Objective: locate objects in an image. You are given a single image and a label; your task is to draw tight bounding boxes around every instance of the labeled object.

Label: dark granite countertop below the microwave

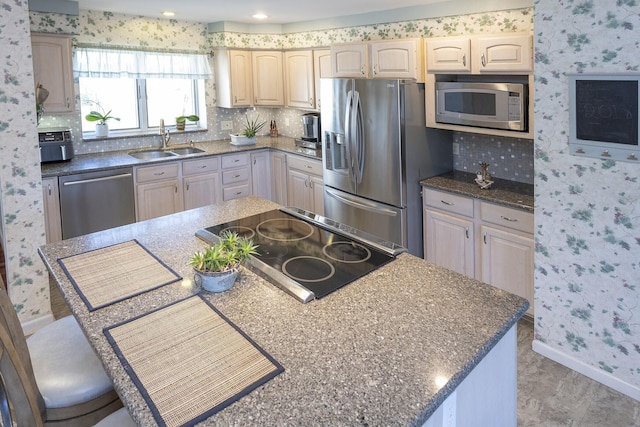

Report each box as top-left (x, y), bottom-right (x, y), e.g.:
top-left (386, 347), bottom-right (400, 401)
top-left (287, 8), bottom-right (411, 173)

top-left (420, 171), bottom-right (534, 212)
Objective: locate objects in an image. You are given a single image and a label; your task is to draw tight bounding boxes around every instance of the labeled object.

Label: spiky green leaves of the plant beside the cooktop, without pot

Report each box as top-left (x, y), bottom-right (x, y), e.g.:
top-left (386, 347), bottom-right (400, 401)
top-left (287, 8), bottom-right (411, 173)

top-left (189, 231), bottom-right (258, 273)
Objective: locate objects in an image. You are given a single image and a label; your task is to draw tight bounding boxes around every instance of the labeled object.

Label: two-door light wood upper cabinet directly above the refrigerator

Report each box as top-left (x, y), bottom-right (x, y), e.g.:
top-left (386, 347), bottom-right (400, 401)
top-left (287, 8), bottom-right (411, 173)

top-left (331, 39), bottom-right (423, 82)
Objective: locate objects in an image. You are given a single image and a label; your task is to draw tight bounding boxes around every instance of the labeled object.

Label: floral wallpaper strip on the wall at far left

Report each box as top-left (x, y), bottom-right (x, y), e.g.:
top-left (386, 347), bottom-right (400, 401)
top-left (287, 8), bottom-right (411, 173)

top-left (0, 0), bottom-right (50, 321)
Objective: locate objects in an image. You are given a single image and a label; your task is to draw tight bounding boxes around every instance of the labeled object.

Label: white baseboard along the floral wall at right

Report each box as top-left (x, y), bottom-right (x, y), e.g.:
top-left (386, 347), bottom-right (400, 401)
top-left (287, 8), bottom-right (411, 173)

top-left (532, 340), bottom-right (640, 400)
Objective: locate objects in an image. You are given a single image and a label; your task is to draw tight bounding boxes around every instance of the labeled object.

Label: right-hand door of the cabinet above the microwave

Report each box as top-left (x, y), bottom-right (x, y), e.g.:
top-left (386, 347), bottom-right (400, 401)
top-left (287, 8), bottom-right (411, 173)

top-left (471, 35), bottom-right (533, 73)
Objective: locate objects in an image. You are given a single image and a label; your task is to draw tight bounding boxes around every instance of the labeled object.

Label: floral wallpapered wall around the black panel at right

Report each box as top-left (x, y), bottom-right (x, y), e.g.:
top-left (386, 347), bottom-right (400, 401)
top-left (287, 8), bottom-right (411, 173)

top-left (534, 0), bottom-right (640, 398)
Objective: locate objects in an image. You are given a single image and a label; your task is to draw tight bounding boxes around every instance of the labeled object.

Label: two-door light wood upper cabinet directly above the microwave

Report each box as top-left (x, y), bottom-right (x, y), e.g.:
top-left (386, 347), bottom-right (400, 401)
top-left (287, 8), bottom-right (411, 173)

top-left (425, 33), bottom-right (533, 74)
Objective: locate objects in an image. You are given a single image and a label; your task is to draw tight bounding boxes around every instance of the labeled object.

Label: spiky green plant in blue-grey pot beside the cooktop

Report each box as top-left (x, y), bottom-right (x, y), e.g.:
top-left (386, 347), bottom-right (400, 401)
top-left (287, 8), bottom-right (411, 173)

top-left (189, 231), bottom-right (257, 292)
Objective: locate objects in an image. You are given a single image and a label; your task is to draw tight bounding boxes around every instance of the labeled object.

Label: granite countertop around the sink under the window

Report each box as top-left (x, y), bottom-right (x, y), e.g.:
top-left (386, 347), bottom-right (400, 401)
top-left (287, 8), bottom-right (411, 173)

top-left (41, 136), bottom-right (322, 178)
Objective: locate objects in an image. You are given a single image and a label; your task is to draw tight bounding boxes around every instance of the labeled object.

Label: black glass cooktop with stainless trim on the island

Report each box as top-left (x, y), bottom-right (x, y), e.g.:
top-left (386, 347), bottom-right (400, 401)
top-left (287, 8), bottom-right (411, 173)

top-left (196, 208), bottom-right (406, 303)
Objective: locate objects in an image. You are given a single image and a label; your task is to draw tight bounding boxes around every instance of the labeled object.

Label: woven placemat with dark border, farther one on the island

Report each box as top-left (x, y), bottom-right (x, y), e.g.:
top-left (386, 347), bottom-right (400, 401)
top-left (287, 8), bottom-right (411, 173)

top-left (58, 240), bottom-right (182, 311)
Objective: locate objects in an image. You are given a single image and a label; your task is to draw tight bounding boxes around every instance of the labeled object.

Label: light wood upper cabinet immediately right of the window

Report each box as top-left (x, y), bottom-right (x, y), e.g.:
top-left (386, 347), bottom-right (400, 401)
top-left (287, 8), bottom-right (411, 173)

top-left (213, 49), bottom-right (284, 108)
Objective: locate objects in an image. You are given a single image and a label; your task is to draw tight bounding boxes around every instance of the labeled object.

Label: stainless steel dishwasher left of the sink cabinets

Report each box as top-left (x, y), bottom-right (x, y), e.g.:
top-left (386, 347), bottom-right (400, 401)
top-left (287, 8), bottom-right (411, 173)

top-left (58, 168), bottom-right (136, 239)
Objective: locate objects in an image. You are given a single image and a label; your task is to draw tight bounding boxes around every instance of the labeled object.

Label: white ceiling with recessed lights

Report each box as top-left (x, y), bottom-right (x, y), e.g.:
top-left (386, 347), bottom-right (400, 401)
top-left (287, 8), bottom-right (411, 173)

top-left (78, 0), bottom-right (452, 24)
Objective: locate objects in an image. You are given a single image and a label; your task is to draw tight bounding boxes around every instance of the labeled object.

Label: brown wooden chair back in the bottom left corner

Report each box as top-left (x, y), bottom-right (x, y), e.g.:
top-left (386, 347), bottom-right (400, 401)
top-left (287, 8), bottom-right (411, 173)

top-left (0, 278), bottom-right (45, 426)
